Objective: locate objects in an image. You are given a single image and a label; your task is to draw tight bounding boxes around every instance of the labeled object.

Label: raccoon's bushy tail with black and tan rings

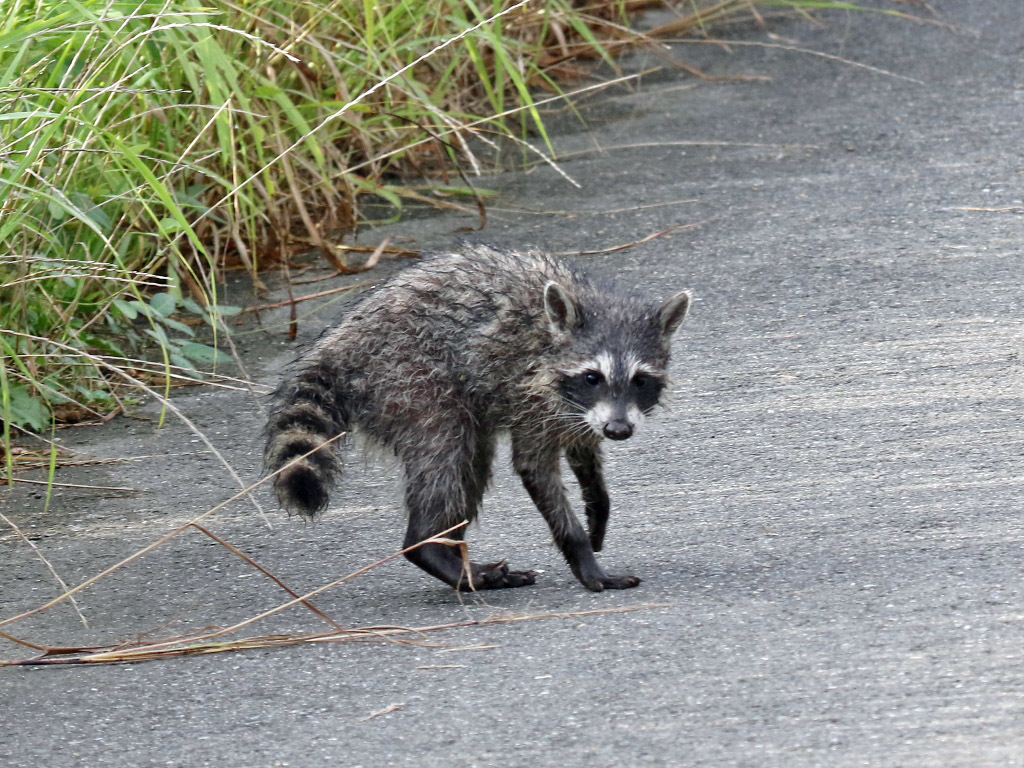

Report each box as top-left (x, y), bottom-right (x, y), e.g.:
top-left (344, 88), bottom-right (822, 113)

top-left (263, 361), bottom-right (348, 519)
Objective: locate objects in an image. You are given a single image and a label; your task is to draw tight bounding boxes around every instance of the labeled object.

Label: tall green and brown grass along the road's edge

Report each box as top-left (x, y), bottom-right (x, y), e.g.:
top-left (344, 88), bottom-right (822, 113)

top-left (0, 0), bottom-right (913, 456)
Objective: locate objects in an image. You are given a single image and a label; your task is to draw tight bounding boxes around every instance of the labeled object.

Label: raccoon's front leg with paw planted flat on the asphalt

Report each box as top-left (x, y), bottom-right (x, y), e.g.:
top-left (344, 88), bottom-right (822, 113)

top-left (512, 436), bottom-right (640, 592)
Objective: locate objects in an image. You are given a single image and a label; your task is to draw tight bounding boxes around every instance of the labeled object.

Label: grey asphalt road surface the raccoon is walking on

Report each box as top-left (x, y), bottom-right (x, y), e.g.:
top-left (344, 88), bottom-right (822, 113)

top-left (0, 0), bottom-right (1024, 768)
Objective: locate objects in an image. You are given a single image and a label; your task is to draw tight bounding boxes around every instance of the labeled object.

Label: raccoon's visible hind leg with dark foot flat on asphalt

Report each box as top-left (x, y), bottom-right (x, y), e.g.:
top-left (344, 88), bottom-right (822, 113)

top-left (404, 433), bottom-right (537, 590)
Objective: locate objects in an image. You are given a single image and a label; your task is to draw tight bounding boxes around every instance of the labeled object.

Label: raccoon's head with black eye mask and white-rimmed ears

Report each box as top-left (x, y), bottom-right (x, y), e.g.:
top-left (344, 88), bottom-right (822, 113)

top-left (544, 281), bottom-right (690, 440)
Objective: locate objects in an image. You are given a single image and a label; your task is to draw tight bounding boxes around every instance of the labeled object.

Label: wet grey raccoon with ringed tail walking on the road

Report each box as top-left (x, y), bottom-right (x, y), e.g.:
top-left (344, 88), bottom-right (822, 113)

top-left (264, 245), bottom-right (689, 592)
